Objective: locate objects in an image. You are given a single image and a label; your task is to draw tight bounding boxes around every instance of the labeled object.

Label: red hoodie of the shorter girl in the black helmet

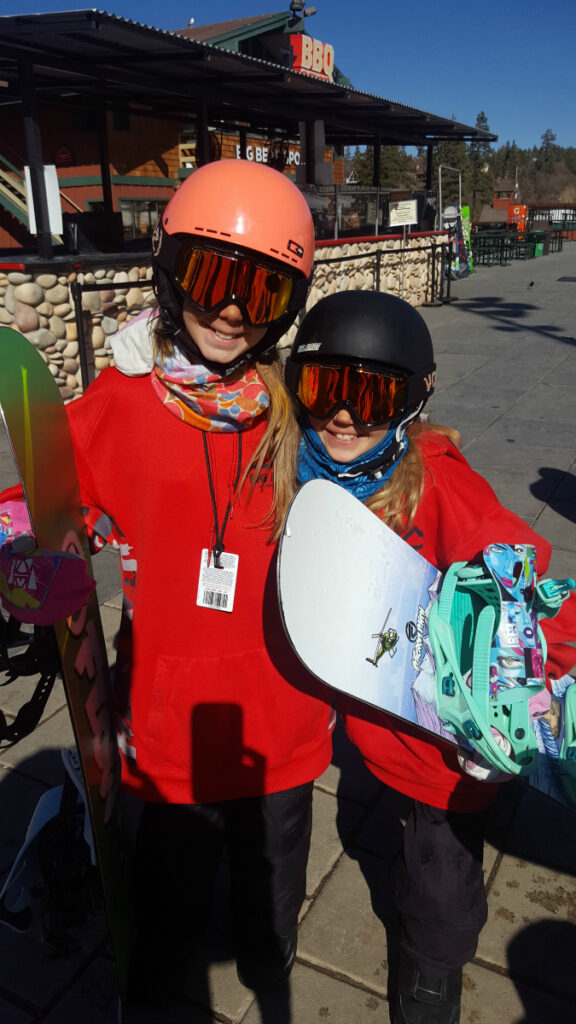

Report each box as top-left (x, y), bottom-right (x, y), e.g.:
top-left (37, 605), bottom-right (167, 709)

top-left (345, 431), bottom-right (576, 811)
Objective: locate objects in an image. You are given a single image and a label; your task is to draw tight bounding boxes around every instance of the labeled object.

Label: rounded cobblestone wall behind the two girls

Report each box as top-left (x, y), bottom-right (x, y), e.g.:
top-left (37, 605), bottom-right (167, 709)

top-left (0, 236), bottom-right (447, 400)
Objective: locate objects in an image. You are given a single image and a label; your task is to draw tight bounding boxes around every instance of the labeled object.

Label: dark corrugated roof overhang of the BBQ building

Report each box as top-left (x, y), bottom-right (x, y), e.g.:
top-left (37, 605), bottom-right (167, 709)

top-left (0, 10), bottom-right (497, 146)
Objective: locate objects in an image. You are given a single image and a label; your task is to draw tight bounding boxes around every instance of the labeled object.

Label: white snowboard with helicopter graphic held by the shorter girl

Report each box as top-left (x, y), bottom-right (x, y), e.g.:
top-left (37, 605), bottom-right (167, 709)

top-left (278, 480), bottom-right (576, 807)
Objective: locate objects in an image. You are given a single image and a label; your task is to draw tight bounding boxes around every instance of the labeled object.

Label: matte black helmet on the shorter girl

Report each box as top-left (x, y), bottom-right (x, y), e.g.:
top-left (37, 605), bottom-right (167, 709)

top-left (286, 292), bottom-right (436, 416)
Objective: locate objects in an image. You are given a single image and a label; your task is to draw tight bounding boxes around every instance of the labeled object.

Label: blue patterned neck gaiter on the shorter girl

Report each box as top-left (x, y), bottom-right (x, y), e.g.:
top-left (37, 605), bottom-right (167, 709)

top-left (298, 413), bottom-right (408, 502)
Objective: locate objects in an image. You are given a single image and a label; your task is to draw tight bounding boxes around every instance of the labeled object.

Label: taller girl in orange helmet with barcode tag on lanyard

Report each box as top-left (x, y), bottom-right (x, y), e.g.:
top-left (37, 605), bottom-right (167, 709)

top-left (63, 161), bottom-right (331, 1004)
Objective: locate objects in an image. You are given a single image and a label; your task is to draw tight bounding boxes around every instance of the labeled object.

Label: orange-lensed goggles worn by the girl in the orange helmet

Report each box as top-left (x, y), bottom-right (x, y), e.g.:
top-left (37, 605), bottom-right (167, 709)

top-left (168, 244), bottom-right (307, 327)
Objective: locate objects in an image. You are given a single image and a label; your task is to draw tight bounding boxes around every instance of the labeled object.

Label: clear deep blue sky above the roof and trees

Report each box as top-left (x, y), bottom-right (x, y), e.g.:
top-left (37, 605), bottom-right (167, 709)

top-left (0, 0), bottom-right (576, 148)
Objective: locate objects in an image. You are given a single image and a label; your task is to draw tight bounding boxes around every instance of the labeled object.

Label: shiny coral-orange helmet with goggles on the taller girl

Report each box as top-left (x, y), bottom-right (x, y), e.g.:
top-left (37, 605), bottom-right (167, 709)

top-left (153, 160), bottom-right (315, 371)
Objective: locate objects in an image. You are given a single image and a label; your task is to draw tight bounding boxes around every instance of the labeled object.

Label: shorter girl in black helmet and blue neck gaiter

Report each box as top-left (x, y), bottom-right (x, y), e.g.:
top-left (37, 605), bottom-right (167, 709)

top-left (286, 292), bottom-right (576, 1024)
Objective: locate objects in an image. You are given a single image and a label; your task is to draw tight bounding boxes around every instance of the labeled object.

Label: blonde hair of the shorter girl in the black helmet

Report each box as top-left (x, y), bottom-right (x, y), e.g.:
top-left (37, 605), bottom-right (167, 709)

top-left (365, 420), bottom-right (461, 534)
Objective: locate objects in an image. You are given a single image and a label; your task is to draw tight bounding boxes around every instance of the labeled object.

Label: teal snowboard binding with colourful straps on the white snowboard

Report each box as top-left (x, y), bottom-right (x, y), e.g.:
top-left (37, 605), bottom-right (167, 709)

top-left (428, 544), bottom-right (576, 775)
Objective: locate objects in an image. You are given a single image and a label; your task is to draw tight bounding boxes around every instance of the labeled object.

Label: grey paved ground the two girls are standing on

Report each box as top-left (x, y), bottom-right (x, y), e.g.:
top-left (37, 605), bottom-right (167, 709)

top-left (0, 244), bottom-right (576, 1024)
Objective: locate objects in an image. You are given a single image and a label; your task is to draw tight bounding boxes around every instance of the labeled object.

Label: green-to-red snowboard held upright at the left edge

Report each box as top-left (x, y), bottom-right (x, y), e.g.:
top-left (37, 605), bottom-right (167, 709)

top-left (0, 328), bottom-right (132, 995)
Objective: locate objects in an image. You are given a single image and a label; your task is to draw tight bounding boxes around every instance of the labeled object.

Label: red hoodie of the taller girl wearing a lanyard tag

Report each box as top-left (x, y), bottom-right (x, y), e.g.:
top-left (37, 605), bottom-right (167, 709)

top-left (68, 370), bottom-right (331, 803)
